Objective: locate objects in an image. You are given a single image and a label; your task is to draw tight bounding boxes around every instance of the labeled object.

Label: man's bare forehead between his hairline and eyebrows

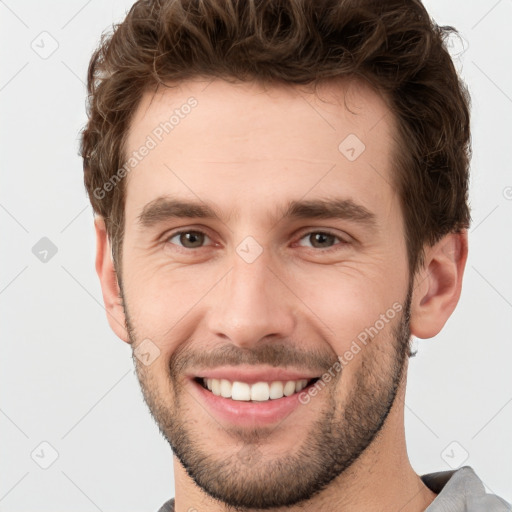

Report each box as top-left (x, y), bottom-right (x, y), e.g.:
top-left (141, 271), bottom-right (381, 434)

top-left (125, 79), bottom-right (395, 224)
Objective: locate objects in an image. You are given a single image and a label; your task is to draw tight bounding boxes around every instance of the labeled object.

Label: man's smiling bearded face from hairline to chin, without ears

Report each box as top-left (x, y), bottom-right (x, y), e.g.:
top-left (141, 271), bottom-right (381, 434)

top-left (121, 80), bottom-right (411, 508)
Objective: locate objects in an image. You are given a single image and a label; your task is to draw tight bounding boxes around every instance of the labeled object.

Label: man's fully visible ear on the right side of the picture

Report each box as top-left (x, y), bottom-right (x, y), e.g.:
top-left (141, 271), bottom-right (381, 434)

top-left (410, 230), bottom-right (468, 339)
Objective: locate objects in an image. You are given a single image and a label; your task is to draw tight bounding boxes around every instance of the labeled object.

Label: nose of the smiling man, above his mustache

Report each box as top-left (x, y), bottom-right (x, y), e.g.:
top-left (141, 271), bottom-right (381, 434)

top-left (208, 245), bottom-right (297, 348)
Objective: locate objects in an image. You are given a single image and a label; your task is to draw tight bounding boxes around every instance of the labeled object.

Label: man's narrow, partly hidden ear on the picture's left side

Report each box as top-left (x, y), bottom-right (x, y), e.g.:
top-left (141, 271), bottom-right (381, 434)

top-left (94, 215), bottom-right (130, 343)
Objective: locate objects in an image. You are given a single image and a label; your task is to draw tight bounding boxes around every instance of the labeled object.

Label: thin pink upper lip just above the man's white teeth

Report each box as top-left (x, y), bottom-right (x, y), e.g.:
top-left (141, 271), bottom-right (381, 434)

top-left (190, 366), bottom-right (318, 384)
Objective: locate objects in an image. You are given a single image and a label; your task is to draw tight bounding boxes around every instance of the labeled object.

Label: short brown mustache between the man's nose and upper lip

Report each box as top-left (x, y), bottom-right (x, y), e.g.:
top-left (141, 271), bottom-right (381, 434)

top-left (169, 343), bottom-right (338, 376)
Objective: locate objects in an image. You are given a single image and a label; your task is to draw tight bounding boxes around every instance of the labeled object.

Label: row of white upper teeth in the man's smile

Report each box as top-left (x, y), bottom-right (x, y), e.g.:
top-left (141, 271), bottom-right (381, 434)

top-left (203, 379), bottom-right (308, 402)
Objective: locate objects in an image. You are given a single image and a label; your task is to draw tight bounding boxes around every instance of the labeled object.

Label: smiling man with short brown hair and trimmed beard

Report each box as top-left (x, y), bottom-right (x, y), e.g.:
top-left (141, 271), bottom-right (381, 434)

top-left (82, 0), bottom-right (510, 512)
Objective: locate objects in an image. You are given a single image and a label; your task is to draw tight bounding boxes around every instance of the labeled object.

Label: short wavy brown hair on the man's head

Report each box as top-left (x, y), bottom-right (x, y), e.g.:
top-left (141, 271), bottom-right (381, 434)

top-left (80, 0), bottom-right (471, 278)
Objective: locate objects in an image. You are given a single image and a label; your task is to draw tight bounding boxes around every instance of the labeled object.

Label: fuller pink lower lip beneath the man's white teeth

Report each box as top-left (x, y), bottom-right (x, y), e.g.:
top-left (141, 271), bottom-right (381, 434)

top-left (191, 380), bottom-right (309, 427)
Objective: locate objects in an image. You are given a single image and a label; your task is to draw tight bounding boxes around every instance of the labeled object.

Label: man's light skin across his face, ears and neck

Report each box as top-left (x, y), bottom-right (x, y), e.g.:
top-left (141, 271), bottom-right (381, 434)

top-left (95, 80), bottom-right (467, 512)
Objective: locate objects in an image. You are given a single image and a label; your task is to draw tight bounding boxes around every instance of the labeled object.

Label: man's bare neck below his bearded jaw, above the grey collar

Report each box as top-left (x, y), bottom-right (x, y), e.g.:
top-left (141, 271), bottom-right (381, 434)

top-left (174, 364), bottom-right (436, 512)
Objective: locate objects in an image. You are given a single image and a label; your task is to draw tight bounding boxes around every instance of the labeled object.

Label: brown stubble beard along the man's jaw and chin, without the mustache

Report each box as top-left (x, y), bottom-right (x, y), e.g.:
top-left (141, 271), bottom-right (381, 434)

top-left (123, 286), bottom-right (412, 511)
